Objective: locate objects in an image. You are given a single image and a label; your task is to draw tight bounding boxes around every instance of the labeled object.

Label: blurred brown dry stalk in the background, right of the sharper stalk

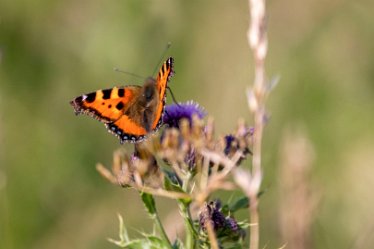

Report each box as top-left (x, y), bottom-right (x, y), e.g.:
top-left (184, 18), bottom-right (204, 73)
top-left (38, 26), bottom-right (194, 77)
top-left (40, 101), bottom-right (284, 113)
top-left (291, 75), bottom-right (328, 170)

top-left (279, 130), bottom-right (319, 249)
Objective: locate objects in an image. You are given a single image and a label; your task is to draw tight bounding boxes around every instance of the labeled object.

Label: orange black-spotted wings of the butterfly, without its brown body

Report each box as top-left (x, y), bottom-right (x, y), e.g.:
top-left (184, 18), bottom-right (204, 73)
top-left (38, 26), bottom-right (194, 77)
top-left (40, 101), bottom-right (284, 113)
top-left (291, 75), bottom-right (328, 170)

top-left (70, 57), bottom-right (174, 143)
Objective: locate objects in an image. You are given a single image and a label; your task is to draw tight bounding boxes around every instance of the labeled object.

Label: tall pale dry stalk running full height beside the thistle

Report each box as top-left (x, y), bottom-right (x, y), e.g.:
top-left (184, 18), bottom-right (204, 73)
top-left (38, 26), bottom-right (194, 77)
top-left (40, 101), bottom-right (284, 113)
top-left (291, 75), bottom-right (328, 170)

top-left (247, 0), bottom-right (268, 249)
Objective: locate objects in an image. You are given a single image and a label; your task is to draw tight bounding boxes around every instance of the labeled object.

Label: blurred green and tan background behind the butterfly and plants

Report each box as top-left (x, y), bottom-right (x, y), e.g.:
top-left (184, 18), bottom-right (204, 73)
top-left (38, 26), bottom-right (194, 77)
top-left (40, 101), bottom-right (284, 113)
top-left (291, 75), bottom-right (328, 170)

top-left (0, 0), bottom-right (374, 249)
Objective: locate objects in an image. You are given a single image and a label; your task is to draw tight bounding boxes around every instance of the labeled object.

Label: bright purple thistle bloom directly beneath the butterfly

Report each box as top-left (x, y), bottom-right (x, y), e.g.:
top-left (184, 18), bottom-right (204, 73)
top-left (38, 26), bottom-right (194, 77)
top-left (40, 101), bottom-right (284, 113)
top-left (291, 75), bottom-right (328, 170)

top-left (162, 101), bottom-right (206, 128)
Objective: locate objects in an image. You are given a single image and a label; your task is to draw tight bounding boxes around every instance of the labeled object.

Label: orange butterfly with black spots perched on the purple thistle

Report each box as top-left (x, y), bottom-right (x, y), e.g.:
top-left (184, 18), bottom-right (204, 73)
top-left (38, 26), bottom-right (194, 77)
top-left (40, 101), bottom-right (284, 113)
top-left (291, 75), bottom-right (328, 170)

top-left (70, 57), bottom-right (174, 144)
